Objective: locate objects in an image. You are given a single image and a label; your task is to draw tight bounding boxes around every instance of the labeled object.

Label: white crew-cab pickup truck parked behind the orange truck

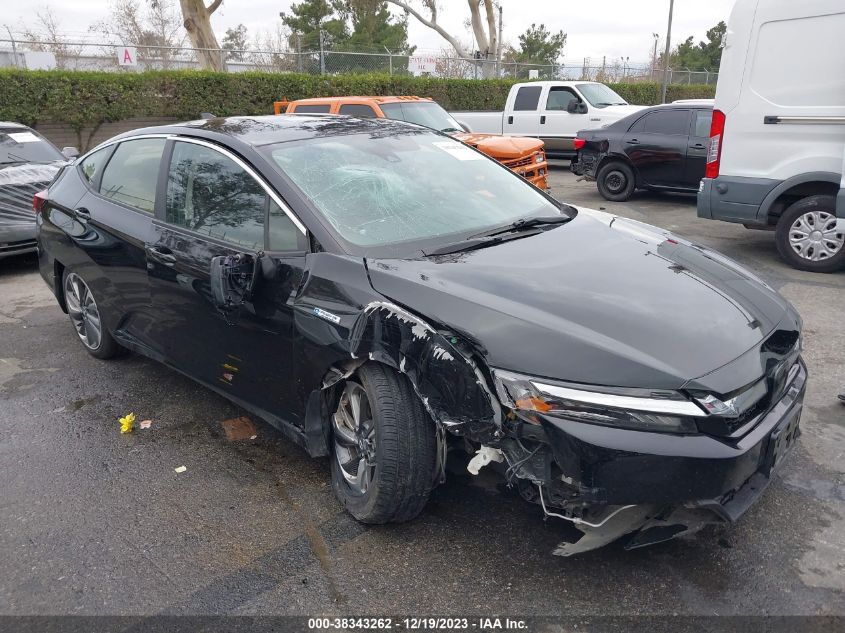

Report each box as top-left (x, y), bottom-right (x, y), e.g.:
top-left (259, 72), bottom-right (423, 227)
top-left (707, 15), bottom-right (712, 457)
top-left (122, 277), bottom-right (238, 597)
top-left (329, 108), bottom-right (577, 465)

top-left (451, 81), bottom-right (645, 157)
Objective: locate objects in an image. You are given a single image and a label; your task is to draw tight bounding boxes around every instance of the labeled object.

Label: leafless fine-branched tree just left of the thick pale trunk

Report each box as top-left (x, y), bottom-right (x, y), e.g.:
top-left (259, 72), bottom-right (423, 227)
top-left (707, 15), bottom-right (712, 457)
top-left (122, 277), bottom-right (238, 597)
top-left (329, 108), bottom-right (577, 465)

top-left (88, 0), bottom-right (185, 69)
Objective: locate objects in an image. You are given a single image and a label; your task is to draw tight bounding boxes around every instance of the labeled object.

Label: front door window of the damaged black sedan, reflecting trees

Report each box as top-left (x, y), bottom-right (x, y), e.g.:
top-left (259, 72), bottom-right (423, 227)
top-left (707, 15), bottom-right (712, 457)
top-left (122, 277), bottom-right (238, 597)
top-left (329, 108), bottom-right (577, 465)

top-left (165, 141), bottom-right (269, 250)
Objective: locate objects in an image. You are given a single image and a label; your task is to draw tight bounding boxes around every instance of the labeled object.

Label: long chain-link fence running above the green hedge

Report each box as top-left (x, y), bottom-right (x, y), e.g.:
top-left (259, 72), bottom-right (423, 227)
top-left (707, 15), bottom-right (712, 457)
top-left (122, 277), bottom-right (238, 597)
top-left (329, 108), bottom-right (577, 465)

top-left (0, 39), bottom-right (719, 84)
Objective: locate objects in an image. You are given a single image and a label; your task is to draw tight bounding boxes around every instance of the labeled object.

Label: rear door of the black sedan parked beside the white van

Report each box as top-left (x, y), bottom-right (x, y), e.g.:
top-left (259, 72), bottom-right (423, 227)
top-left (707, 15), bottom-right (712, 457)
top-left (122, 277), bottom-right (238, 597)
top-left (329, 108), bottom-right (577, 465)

top-left (622, 108), bottom-right (690, 187)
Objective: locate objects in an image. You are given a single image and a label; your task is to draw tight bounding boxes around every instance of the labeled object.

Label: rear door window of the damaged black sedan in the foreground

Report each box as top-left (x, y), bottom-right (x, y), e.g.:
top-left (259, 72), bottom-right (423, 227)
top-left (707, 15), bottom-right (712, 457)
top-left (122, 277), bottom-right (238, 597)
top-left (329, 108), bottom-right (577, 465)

top-left (100, 138), bottom-right (165, 215)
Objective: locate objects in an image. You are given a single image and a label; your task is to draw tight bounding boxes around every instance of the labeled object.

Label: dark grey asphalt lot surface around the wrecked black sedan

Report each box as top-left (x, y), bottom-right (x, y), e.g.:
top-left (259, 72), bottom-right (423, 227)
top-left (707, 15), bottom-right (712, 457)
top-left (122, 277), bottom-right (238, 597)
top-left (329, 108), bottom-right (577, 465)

top-left (0, 161), bottom-right (845, 616)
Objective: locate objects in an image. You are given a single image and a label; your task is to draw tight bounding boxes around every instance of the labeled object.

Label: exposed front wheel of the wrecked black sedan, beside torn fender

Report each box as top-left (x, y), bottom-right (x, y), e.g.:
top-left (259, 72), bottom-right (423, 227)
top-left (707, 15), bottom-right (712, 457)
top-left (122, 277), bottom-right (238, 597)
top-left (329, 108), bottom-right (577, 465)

top-left (331, 363), bottom-right (437, 523)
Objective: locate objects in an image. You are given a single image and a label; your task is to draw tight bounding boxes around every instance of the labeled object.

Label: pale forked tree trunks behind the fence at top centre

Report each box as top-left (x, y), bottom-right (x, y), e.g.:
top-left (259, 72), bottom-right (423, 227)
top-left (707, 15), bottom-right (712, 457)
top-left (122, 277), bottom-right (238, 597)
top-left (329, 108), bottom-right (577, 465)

top-left (387, 0), bottom-right (499, 77)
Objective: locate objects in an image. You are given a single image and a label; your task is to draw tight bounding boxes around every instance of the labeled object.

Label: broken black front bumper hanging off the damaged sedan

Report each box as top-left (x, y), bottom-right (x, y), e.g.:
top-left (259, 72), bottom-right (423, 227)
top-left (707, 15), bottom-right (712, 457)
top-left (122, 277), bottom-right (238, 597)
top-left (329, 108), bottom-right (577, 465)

top-left (541, 361), bottom-right (807, 556)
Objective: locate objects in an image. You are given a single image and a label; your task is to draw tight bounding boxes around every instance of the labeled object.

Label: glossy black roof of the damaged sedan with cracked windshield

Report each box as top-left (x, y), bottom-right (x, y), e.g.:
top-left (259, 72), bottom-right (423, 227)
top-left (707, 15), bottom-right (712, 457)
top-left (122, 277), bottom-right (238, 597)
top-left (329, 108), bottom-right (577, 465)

top-left (109, 114), bottom-right (420, 147)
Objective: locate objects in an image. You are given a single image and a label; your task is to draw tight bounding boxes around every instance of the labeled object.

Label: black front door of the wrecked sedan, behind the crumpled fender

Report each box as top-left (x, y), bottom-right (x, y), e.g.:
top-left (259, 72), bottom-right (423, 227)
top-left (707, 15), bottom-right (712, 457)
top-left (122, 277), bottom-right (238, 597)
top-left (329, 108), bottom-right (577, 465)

top-left (147, 139), bottom-right (305, 423)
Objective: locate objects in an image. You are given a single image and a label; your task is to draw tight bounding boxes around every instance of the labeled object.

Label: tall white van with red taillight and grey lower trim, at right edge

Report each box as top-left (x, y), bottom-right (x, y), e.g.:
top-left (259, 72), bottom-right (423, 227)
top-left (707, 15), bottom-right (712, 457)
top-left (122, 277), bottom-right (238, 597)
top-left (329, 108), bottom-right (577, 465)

top-left (698, 0), bottom-right (845, 272)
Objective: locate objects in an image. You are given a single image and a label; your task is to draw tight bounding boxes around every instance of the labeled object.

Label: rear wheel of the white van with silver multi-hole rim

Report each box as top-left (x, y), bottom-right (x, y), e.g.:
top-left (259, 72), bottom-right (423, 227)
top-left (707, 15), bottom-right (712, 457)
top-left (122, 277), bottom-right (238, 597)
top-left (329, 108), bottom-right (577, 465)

top-left (775, 195), bottom-right (845, 273)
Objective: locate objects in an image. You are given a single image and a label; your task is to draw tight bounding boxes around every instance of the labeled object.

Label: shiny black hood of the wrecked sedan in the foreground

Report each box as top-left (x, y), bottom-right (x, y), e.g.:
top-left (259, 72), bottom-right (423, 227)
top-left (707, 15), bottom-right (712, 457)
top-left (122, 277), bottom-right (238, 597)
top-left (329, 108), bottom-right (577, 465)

top-left (367, 209), bottom-right (798, 389)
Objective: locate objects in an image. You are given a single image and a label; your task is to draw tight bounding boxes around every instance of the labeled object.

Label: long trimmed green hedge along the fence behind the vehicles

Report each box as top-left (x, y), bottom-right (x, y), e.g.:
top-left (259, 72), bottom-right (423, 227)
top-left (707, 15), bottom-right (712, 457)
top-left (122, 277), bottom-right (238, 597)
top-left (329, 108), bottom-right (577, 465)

top-left (0, 69), bottom-right (714, 132)
